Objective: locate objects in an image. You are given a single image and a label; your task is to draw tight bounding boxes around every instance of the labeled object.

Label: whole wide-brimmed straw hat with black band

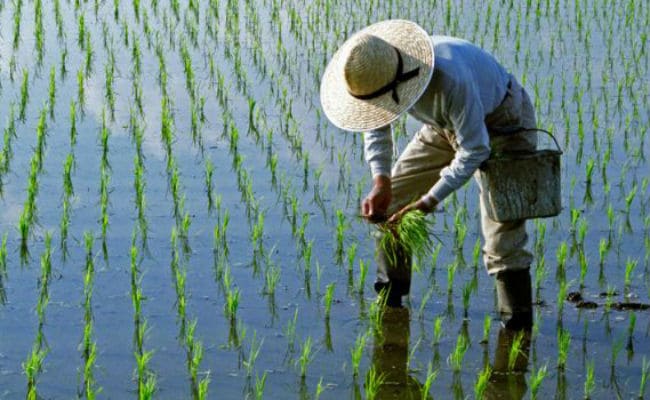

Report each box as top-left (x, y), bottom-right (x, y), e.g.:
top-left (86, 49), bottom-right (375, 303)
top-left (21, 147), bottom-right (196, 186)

top-left (320, 20), bottom-right (433, 131)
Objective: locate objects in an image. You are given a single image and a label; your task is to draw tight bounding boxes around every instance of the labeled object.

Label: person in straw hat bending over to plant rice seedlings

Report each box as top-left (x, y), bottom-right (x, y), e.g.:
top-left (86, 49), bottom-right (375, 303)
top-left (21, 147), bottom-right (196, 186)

top-left (320, 20), bottom-right (536, 329)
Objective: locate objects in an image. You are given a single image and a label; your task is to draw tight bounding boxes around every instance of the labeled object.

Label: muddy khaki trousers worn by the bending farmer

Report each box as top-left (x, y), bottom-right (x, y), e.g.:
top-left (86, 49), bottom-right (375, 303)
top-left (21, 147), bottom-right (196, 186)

top-left (388, 78), bottom-right (537, 275)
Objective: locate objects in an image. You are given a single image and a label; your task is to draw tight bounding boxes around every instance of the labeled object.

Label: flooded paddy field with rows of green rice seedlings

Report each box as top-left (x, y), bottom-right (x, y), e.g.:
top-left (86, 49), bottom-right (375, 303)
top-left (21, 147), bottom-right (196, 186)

top-left (0, 0), bottom-right (650, 399)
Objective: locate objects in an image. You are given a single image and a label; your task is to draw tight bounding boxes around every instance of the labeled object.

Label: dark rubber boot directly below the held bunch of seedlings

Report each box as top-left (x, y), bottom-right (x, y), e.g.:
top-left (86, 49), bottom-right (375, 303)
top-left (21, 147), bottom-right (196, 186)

top-left (375, 238), bottom-right (411, 307)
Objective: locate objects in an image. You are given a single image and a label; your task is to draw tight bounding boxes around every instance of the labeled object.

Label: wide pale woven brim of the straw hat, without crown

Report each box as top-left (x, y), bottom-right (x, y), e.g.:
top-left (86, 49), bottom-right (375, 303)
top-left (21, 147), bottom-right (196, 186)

top-left (320, 20), bottom-right (434, 132)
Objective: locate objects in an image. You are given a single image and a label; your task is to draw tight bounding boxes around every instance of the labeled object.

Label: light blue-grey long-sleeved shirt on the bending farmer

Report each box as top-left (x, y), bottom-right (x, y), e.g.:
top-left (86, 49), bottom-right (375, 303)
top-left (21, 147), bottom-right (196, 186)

top-left (364, 36), bottom-right (510, 202)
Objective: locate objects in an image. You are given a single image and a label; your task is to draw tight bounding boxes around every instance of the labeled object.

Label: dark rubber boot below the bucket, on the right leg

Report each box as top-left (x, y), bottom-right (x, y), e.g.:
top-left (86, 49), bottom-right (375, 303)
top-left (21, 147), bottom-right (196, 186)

top-left (496, 268), bottom-right (533, 330)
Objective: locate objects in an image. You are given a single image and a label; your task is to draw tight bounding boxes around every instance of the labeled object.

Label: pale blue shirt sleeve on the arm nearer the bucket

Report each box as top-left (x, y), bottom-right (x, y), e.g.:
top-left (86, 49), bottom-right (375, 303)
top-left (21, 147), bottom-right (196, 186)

top-left (425, 78), bottom-right (490, 202)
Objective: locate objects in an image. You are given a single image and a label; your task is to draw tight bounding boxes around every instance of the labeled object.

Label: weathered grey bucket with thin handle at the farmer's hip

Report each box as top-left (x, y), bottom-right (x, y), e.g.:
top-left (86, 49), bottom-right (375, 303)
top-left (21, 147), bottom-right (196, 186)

top-left (479, 129), bottom-right (562, 222)
